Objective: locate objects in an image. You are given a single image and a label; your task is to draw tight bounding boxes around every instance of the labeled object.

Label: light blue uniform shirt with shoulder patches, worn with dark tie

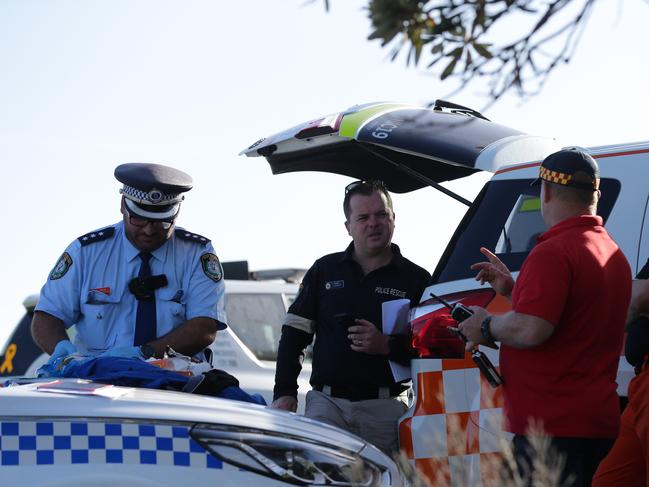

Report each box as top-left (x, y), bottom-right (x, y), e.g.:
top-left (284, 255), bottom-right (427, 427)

top-left (36, 222), bottom-right (227, 354)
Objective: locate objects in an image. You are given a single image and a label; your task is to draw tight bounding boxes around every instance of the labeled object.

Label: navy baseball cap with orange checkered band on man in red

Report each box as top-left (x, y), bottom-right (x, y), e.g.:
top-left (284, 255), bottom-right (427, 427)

top-left (530, 147), bottom-right (599, 191)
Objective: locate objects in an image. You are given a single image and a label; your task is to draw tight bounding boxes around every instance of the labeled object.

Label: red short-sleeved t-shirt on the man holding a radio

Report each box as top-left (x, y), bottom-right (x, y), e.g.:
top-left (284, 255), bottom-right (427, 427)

top-left (500, 215), bottom-right (632, 438)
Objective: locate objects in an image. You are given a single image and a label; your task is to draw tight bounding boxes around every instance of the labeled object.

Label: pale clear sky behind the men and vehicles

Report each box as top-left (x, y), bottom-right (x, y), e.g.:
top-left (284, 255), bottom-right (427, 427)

top-left (0, 0), bottom-right (649, 346)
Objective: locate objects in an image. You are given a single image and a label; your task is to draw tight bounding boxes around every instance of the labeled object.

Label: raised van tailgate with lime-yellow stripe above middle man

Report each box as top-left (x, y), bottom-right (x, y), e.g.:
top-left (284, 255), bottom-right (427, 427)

top-left (241, 103), bottom-right (557, 193)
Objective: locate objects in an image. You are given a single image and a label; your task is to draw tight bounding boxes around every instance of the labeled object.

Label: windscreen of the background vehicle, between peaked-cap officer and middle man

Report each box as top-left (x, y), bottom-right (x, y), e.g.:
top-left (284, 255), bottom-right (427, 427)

top-left (225, 293), bottom-right (286, 360)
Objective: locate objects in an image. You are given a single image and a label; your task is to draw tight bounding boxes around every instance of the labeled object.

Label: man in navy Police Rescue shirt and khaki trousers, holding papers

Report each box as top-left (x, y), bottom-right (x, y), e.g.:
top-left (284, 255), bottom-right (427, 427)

top-left (272, 181), bottom-right (430, 453)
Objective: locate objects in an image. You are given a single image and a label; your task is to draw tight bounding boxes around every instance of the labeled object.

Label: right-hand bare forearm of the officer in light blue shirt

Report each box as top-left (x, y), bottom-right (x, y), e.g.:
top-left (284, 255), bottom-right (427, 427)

top-left (149, 317), bottom-right (216, 357)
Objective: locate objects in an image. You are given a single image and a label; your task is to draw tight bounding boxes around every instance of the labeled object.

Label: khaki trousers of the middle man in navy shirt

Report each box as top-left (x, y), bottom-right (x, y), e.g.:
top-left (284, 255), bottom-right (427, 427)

top-left (304, 391), bottom-right (408, 456)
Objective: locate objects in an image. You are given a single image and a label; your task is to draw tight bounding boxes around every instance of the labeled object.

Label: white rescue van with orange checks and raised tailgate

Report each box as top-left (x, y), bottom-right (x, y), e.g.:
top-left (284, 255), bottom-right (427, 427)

top-left (242, 101), bottom-right (649, 485)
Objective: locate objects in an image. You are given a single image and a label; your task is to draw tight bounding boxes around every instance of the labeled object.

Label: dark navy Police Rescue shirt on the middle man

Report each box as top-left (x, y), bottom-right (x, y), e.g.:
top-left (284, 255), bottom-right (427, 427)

top-left (289, 242), bottom-right (430, 387)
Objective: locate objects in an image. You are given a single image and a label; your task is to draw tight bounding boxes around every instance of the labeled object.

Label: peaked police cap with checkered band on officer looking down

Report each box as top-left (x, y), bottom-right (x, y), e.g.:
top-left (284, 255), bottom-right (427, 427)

top-left (115, 162), bottom-right (193, 220)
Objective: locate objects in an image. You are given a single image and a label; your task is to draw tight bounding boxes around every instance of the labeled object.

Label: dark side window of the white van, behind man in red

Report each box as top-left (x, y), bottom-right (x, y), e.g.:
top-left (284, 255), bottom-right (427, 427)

top-left (432, 179), bottom-right (620, 283)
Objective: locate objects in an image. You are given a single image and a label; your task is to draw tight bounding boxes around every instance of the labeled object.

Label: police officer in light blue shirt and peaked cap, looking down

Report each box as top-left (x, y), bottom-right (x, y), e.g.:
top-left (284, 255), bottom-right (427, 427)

top-left (32, 163), bottom-right (226, 362)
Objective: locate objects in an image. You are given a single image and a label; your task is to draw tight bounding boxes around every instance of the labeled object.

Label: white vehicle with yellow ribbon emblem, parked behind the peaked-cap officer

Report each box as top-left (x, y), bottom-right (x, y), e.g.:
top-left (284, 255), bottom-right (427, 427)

top-left (0, 263), bottom-right (311, 408)
